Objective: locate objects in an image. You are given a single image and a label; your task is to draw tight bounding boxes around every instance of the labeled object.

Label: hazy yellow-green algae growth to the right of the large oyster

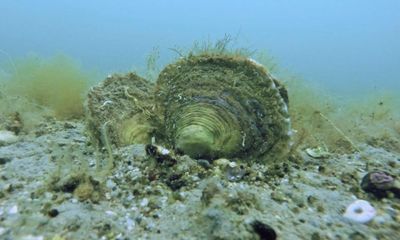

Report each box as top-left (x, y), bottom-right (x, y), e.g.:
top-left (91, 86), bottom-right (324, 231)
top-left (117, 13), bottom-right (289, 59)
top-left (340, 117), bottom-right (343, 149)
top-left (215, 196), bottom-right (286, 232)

top-left (284, 77), bottom-right (400, 153)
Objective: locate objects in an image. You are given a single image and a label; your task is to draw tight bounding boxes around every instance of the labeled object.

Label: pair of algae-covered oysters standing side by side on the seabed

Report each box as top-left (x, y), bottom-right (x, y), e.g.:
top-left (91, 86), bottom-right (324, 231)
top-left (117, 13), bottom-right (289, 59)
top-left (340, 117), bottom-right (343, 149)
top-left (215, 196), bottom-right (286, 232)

top-left (87, 54), bottom-right (291, 162)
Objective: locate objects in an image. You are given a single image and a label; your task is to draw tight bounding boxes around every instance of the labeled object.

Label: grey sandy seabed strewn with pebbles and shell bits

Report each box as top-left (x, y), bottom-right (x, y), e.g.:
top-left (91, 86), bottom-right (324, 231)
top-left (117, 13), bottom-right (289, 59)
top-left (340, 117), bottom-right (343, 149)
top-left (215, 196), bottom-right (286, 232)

top-left (0, 121), bottom-right (400, 240)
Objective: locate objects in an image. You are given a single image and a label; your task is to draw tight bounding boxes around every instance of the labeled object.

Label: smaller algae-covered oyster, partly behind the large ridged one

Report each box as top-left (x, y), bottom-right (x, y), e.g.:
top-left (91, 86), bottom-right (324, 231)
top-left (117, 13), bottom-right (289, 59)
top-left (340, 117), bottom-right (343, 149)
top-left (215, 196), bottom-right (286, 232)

top-left (86, 73), bottom-right (156, 147)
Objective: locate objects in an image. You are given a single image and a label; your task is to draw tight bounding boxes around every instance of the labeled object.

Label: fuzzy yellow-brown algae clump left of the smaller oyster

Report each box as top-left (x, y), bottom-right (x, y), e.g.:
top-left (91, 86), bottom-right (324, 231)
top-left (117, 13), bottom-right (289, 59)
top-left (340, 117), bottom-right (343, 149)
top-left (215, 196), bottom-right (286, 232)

top-left (5, 55), bottom-right (91, 119)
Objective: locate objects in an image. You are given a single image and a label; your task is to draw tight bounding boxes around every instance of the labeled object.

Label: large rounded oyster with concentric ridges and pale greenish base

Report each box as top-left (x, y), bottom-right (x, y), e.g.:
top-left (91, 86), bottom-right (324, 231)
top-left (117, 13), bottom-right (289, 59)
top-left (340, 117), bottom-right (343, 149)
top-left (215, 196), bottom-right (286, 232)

top-left (155, 54), bottom-right (291, 160)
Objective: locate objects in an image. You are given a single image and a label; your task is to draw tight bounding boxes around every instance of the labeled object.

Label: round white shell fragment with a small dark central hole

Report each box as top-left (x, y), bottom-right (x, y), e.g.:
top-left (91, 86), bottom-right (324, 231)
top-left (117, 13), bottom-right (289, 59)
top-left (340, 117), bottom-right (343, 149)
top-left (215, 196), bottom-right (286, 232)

top-left (343, 200), bottom-right (376, 223)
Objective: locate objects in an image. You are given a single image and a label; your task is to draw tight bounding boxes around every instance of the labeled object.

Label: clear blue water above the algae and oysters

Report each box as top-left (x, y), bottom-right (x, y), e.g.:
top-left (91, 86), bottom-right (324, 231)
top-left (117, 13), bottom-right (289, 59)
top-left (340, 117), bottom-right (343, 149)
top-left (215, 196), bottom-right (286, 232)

top-left (0, 0), bottom-right (400, 94)
